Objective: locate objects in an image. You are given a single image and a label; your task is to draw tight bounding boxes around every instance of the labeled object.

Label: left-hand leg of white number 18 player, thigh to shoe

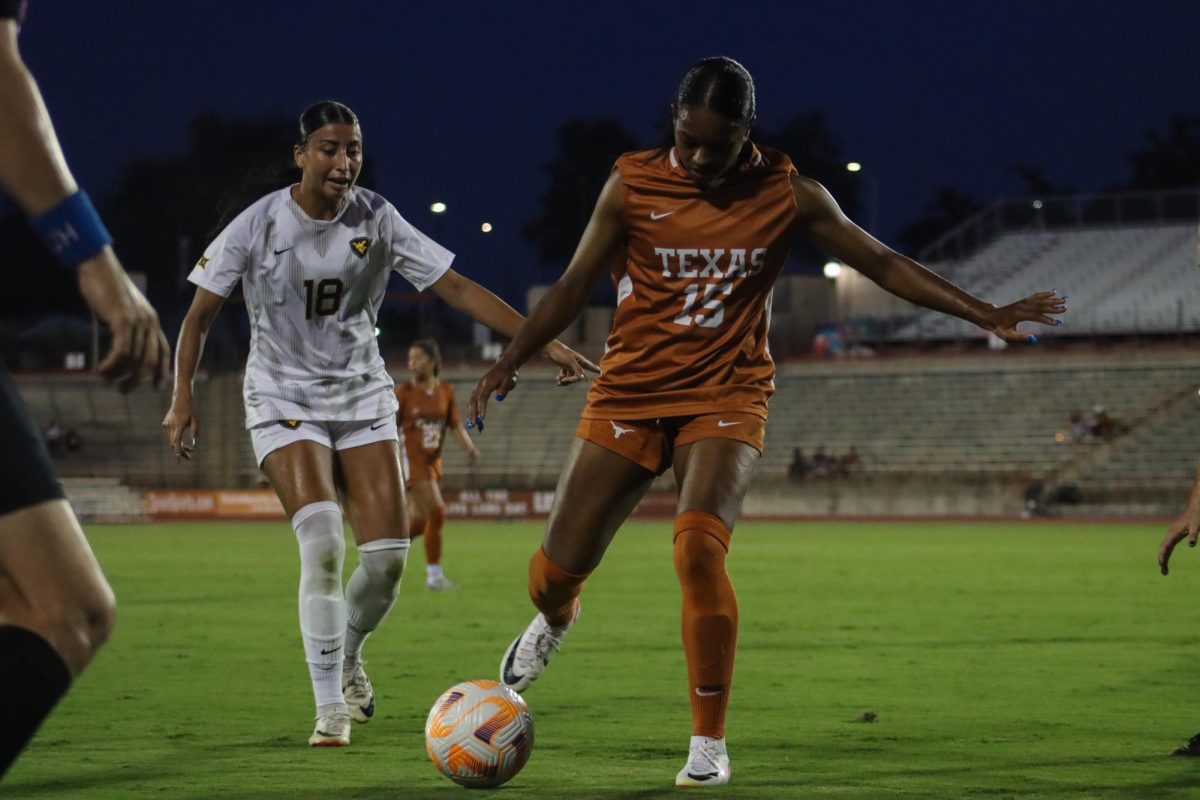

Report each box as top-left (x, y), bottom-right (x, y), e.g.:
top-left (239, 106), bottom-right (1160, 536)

top-left (251, 434), bottom-right (350, 747)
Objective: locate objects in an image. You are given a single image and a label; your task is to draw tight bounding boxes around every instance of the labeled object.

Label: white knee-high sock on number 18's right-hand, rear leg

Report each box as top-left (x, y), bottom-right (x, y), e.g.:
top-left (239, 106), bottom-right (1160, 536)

top-left (344, 539), bottom-right (409, 669)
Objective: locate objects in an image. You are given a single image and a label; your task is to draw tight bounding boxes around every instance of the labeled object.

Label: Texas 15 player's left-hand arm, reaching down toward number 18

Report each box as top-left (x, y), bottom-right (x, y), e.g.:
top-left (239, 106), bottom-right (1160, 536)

top-left (467, 170), bottom-right (624, 431)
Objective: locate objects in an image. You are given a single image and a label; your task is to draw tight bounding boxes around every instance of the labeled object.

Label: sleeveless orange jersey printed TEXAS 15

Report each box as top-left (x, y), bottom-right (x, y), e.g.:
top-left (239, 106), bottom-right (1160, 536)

top-left (583, 146), bottom-right (798, 420)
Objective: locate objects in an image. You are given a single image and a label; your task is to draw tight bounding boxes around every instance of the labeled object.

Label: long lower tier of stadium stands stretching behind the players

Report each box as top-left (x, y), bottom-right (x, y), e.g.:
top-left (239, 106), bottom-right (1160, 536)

top-left (20, 350), bottom-right (1200, 513)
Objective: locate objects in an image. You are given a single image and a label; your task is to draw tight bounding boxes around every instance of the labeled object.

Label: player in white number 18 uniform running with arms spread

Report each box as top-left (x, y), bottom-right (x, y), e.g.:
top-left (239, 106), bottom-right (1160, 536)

top-left (163, 101), bottom-right (596, 747)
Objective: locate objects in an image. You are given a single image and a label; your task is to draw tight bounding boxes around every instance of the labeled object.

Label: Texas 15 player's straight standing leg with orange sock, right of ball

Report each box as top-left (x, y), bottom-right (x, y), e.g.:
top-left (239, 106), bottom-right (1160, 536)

top-left (674, 422), bottom-right (761, 787)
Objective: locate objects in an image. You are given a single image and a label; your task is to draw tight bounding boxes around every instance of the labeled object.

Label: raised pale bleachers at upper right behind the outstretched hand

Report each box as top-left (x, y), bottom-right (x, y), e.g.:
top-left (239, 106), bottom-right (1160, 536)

top-left (894, 222), bottom-right (1200, 341)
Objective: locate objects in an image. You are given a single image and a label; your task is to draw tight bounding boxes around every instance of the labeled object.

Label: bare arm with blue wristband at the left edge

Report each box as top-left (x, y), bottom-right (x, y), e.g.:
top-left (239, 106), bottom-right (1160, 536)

top-left (0, 19), bottom-right (170, 391)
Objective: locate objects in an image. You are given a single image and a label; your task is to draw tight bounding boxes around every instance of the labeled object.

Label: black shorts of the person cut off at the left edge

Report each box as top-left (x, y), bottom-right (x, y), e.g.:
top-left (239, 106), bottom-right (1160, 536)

top-left (0, 360), bottom-right (66, 515)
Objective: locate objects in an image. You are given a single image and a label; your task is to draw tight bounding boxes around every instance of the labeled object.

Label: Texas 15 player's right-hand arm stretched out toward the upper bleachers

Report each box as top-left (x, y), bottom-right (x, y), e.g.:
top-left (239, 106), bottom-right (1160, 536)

top-left (792, 175), bottom-right (1067, 342)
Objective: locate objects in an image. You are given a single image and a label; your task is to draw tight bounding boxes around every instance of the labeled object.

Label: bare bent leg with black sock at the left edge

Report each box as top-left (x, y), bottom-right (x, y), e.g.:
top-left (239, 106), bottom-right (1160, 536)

top-left (0, 503), bottom-right (116, 776)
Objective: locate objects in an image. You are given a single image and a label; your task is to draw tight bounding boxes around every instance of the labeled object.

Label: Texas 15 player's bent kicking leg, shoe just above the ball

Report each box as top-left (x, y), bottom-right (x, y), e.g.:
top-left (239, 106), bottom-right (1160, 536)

top-left (500, 434), bottom-right (661, 692)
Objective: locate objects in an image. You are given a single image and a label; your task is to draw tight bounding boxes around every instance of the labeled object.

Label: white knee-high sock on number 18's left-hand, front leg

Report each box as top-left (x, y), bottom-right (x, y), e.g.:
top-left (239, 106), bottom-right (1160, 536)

top-left (292, 500), bottom-right (346, 709)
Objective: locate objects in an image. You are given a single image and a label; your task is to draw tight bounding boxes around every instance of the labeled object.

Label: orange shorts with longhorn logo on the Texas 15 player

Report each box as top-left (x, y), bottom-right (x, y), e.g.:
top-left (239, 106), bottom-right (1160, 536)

top-left (575, 411), bottom-right (767, 475)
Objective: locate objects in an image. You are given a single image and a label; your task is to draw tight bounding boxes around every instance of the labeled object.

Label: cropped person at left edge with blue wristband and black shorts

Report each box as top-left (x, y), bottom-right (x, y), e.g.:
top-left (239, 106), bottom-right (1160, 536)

top-left (0, 0), bottom-right (170, 776)
